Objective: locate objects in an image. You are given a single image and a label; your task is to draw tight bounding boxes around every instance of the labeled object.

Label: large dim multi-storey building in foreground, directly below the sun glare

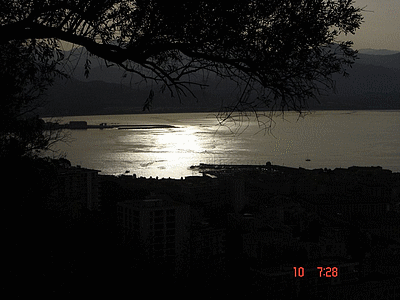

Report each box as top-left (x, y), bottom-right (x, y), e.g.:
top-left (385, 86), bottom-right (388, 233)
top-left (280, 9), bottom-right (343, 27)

top-left (117, 196), bottom-right (190, 274)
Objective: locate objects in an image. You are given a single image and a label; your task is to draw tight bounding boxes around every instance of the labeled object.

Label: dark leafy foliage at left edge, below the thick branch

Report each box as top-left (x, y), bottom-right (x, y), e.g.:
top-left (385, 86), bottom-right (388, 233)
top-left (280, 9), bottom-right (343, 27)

top-left (0, 40), bottom-right (67, 163)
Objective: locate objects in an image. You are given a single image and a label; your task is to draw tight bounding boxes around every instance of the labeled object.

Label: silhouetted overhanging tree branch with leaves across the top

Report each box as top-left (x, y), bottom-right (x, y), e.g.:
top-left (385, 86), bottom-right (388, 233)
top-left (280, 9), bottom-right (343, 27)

top-left (0, 0), bottom-right (362, 117)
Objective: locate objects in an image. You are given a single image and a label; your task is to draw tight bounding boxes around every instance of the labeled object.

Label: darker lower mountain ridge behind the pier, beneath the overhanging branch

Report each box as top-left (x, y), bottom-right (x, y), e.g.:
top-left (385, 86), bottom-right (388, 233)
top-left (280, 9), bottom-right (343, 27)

top-left (38, 79), bottom-right (230, 117)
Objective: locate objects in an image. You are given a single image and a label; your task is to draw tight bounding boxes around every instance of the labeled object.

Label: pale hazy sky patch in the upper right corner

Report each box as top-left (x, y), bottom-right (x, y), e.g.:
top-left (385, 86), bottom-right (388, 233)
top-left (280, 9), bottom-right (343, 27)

top-left (348, 0), bottom-right (400, 51)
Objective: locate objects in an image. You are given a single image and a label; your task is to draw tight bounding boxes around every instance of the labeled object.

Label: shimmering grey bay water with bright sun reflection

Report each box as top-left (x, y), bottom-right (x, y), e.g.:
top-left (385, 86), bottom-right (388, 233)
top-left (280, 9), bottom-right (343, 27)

top-left (48, 111), bottom-right (400, 178)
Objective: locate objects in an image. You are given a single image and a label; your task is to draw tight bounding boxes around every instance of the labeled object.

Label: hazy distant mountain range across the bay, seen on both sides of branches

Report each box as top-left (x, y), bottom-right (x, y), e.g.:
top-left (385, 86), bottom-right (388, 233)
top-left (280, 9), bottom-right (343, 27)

top-left (39, 50), bottom-right (400, 116)
